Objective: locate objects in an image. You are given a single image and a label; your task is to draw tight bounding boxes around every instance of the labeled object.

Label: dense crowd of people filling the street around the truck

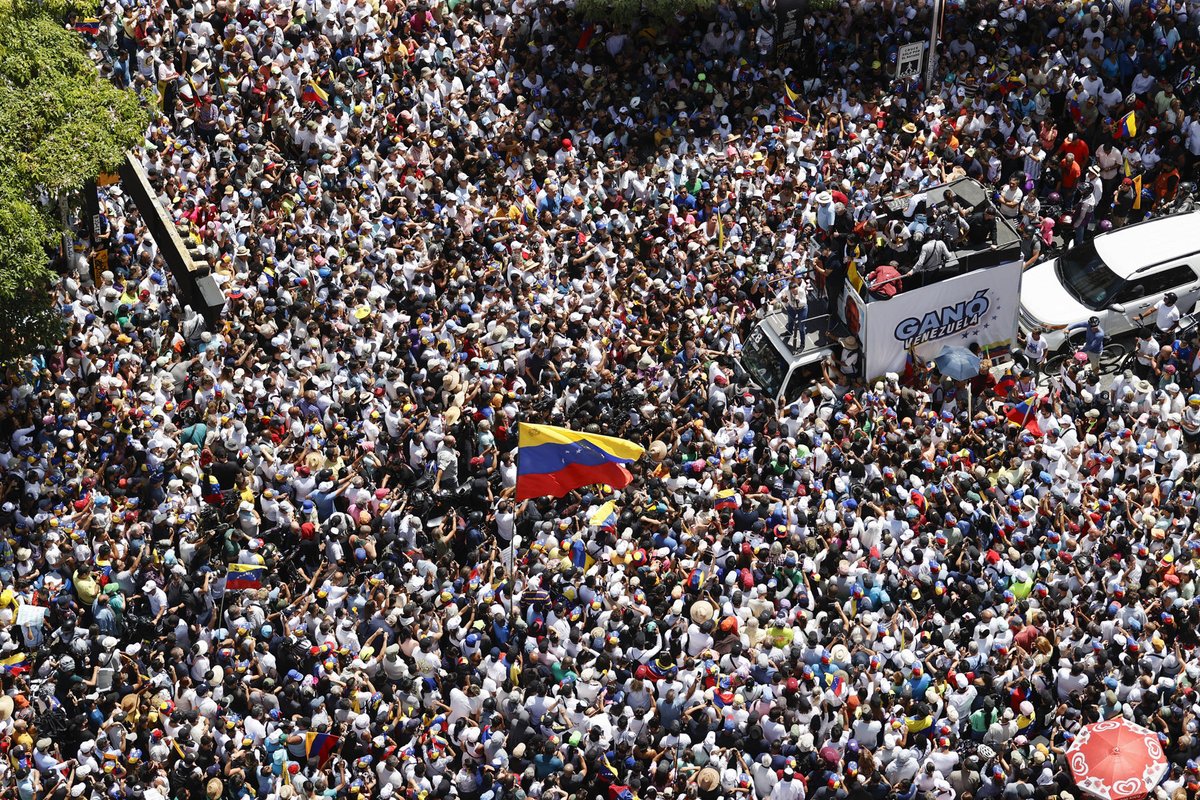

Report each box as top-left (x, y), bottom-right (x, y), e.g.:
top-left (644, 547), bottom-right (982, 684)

top-left (0, 0), bottom-right (1200, 800)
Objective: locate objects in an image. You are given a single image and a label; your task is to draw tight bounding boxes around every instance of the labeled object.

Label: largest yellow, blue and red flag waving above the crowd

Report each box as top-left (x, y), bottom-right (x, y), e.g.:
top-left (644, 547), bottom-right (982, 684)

top-left (517, 422), bottom-right (646, 500)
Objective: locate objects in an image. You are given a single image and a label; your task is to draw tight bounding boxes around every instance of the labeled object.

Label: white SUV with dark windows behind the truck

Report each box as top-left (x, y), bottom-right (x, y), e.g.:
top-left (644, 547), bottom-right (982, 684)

top-left (1020, 211), bottom-right (1200, 363)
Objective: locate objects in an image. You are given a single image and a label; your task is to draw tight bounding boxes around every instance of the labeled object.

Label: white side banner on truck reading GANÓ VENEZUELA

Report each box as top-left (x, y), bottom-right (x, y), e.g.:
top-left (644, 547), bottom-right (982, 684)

top-left (865, 260), bottom-right (1021, 378)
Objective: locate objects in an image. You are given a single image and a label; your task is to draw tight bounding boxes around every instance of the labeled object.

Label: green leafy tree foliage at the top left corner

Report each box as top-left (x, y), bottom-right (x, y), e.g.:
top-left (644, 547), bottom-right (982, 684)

top-left (0, 0), bottom-right (149, 362)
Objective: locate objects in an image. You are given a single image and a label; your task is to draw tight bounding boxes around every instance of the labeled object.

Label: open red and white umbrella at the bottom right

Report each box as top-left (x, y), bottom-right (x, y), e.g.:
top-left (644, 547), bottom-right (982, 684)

top-left (1067, 717), bottom-right (1168, 800)
